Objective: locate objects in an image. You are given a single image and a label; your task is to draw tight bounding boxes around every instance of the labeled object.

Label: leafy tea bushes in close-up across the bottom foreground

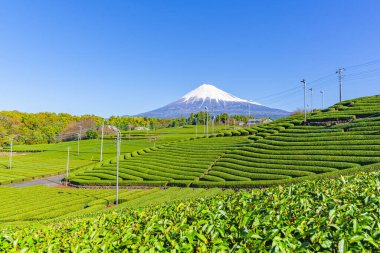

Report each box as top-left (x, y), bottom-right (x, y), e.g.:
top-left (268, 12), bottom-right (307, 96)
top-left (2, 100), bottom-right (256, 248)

top-left (0, 172), bottom-right (380, 252)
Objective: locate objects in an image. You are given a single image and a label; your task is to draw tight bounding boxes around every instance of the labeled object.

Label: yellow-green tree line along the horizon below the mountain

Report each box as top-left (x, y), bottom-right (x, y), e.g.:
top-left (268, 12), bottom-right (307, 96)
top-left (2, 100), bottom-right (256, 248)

top-left (0, 111), bottom-right (253, 146)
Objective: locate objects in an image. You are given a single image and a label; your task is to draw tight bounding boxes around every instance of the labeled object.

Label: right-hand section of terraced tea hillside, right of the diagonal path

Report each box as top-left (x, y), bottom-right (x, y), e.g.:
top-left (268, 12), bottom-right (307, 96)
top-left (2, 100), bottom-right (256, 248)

top-left (198, 117), bottom-right (380, 185)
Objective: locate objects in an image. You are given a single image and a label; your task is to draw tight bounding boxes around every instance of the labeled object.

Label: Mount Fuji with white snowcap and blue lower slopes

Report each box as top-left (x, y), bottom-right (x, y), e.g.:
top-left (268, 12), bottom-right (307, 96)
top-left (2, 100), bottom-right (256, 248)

top-left (136, 84), bottom-right (289, 118)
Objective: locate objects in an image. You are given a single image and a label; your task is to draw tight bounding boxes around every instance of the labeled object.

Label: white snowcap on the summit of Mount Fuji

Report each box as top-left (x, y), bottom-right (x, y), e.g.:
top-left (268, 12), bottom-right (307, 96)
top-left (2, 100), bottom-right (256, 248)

top-left (182, 84), bottom-right (258, 105)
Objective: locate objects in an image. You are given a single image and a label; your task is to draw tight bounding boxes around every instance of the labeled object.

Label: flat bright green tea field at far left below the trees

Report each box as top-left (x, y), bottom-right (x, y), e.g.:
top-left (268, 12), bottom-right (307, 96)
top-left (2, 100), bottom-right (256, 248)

top-left (0, 140), bottom-right (151, 185)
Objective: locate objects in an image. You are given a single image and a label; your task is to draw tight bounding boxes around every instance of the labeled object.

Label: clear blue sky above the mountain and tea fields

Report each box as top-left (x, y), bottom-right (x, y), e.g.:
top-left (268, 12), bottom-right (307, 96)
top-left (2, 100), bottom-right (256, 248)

top-left (0, 0), bottom-right (380, 117)
